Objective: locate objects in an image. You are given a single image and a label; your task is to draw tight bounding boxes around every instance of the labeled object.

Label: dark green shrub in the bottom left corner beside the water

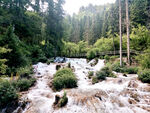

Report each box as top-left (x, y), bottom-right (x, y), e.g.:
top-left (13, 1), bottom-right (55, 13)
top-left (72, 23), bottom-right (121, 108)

top-left (0, 81), bottom-right (18, 107)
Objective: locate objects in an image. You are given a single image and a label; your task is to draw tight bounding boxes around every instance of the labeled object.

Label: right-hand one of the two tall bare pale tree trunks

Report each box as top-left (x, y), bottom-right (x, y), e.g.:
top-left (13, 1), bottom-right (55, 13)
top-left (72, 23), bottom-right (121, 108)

top-left (126, 0), bottom-right (131, 65)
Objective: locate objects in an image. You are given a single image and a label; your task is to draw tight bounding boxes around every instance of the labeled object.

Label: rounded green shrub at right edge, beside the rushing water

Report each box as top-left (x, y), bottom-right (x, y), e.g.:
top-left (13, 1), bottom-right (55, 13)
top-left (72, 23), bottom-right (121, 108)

top-left (138, 69), bottom-right (150, 83)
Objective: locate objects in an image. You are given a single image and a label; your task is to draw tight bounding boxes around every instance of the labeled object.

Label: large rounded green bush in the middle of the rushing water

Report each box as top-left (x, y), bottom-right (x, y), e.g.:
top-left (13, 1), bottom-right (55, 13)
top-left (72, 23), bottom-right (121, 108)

top-left (53, 68), bottom-right (77, 90)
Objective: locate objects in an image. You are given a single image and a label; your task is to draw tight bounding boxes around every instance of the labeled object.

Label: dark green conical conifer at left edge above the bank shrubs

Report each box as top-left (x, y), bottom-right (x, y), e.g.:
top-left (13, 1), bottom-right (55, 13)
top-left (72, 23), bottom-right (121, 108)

top-left (1, 26), bottom-right (28, 74)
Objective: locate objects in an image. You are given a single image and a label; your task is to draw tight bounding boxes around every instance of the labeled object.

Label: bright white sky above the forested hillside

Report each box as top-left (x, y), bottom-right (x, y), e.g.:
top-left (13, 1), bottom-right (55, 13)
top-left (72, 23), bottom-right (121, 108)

top-left (64, 0), bottom-right (116, 15)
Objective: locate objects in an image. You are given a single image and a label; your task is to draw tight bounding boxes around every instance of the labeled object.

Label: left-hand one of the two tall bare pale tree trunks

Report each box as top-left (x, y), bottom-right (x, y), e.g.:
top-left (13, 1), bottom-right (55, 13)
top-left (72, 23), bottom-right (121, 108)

top-left (119, 0), bottom-right (122, 67)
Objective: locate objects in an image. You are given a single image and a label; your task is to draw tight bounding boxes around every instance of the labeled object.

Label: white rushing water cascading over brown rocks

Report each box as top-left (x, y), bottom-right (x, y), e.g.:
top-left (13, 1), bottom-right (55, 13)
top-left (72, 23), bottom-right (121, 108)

top-left (19, 59), bottom-right (150, 113)
